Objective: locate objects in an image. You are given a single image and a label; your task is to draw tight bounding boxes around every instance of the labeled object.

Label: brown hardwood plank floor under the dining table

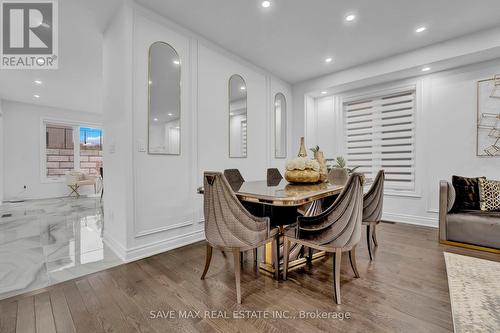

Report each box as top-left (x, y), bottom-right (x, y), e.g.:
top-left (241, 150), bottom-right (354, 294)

top-left (0, 223), bottom-right (500, 333)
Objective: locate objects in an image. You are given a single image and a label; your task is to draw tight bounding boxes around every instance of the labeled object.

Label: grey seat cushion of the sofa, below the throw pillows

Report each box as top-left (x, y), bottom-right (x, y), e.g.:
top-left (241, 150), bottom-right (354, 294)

top-left (446, 210), bottom-right (500, 249)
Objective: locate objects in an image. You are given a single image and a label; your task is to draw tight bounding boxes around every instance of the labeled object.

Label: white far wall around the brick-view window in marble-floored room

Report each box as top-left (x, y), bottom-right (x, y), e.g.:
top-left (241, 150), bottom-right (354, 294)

top-left (2, 100), bottom-right (102, 200)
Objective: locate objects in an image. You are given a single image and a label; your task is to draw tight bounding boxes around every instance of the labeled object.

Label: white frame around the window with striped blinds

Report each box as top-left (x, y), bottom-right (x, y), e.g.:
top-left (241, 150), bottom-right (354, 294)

top-left (337, 80), bottom-right (424, 198)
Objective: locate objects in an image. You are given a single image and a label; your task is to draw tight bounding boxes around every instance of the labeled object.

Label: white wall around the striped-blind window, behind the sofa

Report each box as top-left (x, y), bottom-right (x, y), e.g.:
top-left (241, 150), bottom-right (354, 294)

top-left (305, 59), bottom-right (500, 226)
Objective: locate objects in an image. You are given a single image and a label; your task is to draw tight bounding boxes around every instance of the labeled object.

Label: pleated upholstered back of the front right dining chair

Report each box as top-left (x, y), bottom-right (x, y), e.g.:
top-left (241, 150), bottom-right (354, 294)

top-left (298, 173), bottom-right (363, 248)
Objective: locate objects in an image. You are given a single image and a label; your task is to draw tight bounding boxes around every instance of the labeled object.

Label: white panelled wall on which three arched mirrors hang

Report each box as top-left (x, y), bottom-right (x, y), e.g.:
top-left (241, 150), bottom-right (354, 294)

top-left (104, 3), bottom-right (292, 260)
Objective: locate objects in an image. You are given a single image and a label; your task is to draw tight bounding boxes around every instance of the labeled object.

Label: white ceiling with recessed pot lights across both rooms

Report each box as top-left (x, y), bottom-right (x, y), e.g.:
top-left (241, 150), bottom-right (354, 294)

top-left (0, 0), bottom-right (500, 112)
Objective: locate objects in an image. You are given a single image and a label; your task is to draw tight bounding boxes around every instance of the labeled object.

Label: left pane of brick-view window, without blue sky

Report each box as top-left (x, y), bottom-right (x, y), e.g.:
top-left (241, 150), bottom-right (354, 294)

top-left (46, 124), bottom-right (75, 177)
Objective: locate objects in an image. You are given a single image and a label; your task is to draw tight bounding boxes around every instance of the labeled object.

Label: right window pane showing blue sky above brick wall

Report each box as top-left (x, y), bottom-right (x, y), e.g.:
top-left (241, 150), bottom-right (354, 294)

top-left (80, 127), bottom-right (102, 175)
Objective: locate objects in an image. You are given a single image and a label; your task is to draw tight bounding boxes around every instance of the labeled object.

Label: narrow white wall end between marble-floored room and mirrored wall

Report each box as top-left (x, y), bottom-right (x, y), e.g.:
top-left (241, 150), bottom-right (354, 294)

top-left (103, 2), bottom-right (134, 257)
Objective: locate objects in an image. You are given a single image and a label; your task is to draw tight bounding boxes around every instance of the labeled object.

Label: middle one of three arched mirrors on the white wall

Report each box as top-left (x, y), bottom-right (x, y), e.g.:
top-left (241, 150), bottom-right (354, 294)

top-left (229, 75), bottom-right (247, 157)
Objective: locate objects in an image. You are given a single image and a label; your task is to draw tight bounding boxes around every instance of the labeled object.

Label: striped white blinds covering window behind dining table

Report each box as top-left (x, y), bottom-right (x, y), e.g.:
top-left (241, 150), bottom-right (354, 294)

top-left (344, 89), bottom-right (416, 191)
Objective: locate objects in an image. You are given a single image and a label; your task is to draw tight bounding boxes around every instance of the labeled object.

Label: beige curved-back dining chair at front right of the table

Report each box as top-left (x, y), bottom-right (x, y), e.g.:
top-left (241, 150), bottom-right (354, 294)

top-left (283, 174), bottom-right (363, 304)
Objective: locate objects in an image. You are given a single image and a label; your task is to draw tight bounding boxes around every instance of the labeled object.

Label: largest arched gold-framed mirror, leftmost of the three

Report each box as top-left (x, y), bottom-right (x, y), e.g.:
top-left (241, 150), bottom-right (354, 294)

top-left (148, 42), bottom-right (181, 155)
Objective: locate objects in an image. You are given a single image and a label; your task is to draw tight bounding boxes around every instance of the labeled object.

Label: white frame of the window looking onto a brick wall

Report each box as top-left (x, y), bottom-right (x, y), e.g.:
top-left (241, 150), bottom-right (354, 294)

top-left (39, 117), bottom-right (104, 184)
